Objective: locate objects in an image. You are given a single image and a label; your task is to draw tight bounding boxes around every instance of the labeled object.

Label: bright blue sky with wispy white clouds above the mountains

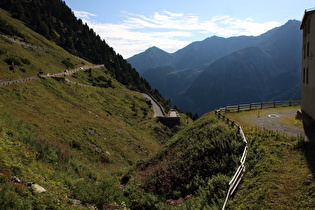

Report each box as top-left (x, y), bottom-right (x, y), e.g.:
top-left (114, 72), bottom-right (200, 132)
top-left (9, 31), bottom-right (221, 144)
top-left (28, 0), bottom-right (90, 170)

top-left (64, 0), bottom-right (315, 59)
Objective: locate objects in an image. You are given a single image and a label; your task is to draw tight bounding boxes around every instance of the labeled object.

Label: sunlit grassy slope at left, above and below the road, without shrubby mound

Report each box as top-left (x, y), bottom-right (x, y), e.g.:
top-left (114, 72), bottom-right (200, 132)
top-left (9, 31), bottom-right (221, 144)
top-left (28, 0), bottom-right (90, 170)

top-left (0, 7), bottom-right (180, 209)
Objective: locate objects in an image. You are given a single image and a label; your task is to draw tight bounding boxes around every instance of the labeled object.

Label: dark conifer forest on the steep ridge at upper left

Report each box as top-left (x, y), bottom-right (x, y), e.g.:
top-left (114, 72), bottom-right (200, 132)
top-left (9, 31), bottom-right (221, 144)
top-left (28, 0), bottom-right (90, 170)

top-left (0, 0), bottom-right (170, 107)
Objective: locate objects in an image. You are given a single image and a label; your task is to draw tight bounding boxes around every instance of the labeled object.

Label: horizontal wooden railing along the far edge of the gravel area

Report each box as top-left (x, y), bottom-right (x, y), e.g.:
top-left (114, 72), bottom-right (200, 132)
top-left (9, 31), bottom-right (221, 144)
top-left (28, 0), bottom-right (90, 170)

top-left (218, 100), bottom-right (301, 113)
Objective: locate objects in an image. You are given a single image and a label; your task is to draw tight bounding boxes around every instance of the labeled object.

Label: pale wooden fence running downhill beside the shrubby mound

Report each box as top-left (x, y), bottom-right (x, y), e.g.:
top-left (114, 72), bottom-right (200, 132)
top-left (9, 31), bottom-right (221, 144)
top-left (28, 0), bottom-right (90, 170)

top-left (215, 108), bottom-right (248, 210)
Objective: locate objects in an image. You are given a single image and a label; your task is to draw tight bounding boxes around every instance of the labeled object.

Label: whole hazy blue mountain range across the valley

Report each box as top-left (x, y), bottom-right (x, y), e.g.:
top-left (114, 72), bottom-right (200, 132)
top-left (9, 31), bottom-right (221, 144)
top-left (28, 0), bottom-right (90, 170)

top-left (128, 20), bottom-right (302, 114)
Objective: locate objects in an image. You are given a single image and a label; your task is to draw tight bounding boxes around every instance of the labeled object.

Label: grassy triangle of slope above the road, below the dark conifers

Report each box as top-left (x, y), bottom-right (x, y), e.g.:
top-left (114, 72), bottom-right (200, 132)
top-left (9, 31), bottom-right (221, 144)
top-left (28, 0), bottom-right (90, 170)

top-left (0, 9), bottom-right (89, 81)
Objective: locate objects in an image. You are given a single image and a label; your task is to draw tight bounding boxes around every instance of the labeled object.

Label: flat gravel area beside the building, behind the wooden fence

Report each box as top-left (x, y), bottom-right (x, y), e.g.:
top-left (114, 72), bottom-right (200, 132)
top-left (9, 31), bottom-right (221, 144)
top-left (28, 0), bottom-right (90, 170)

top-left (227, 106), bottom-right (305, 136)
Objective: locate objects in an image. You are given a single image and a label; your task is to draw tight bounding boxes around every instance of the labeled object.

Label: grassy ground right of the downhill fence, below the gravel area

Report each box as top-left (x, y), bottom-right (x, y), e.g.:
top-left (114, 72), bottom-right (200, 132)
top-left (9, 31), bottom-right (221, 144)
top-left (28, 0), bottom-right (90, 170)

top-left (228, 108), bottom-right (315, 209)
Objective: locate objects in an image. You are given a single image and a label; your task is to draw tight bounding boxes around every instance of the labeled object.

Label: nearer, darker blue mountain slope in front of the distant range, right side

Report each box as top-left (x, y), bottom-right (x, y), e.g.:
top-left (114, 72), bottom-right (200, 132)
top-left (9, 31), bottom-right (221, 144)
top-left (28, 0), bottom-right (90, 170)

top-left (173, 21), bottom-right (301, 114)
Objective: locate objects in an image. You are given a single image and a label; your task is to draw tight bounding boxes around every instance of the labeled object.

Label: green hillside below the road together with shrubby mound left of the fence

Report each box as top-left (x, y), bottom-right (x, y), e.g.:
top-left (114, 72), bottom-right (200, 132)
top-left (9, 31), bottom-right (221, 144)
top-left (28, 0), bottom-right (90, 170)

top-left (0, 78), bottom-right (244, 209)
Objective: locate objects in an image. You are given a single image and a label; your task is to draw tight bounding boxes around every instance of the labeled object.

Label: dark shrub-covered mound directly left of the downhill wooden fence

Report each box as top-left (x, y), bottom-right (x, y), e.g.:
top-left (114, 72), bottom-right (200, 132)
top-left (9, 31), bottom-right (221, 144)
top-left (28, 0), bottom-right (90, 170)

top-left (123, 114), bottom-right (244, 209)
